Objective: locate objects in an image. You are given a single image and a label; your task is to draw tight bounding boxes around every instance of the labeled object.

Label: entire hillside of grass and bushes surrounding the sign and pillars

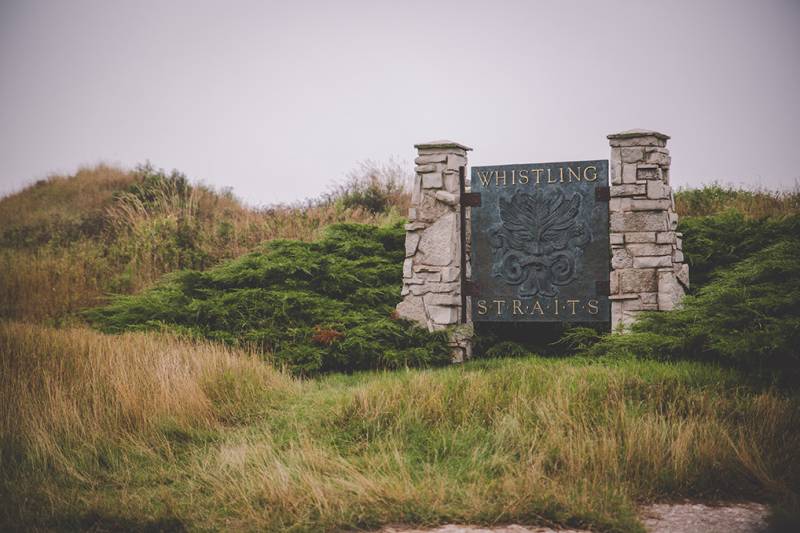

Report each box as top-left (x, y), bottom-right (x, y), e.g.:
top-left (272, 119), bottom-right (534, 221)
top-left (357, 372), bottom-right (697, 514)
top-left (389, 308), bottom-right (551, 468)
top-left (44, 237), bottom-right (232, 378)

top-left (0, 166), bottom-right (800, 531)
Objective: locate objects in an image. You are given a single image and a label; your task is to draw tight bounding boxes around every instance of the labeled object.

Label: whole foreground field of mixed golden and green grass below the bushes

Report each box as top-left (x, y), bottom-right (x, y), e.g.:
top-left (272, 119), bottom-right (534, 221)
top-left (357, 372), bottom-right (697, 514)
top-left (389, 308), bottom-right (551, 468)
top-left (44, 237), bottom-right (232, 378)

top-left (0, 323), bottom-right (800, 531)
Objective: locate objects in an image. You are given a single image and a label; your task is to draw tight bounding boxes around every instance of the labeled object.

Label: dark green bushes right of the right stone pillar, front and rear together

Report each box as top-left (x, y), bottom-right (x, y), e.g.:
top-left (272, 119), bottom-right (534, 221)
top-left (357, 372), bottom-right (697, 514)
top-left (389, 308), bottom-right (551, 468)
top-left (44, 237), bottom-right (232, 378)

top-left (587, 211), bottom-right (800, 384)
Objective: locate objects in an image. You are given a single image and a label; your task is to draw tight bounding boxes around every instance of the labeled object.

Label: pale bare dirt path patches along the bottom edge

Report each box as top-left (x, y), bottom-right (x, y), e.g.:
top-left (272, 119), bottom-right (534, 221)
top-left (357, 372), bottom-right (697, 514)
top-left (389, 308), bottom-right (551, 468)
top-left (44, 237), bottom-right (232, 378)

top-left (379, 503), bottom-right (768, 533)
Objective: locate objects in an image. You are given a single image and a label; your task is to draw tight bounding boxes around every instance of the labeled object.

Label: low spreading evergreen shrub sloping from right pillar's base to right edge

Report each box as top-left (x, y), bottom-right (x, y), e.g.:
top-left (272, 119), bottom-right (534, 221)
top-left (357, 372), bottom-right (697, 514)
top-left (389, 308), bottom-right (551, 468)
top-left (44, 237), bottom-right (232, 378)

top-left (587, 234), bottom-right (800, 383)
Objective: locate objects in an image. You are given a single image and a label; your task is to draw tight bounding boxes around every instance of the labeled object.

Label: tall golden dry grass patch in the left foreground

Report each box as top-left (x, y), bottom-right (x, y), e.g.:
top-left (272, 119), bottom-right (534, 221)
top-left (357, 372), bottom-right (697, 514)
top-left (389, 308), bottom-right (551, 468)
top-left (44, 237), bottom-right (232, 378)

top-left (0, 322), bottom-right (293, 474)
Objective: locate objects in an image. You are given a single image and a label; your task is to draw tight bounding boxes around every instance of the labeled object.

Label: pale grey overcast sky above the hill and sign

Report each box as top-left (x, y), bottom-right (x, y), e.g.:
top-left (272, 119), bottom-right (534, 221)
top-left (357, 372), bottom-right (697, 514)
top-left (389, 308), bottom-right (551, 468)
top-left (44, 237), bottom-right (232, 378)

top-left (0, 0), bottom-right (800, 204)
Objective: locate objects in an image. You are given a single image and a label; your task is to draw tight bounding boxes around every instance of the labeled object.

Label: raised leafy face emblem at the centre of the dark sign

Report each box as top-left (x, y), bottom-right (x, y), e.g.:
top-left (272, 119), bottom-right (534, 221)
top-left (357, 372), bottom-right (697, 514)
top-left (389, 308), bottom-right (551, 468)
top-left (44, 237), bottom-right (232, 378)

top-left (489, 188), bottom-right (592, 297)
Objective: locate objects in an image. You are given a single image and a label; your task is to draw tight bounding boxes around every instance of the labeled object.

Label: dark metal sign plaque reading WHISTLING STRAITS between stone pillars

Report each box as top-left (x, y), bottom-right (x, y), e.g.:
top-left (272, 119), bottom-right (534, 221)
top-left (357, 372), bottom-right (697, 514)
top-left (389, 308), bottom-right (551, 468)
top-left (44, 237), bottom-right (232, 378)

top-left (470, 160), bottom-right (610, 322)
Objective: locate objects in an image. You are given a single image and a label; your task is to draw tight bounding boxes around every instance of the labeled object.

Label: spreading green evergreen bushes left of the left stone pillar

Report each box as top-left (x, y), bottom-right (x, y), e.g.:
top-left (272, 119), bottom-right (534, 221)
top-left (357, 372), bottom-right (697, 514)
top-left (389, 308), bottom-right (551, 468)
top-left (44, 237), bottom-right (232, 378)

top-left (87, 220), bottom-right (449, 374)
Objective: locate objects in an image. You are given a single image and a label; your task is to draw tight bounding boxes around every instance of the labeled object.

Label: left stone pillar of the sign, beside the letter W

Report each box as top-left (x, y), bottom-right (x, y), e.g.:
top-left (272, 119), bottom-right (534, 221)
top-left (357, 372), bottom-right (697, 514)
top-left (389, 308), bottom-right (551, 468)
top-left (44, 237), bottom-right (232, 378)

top-left (397, 141), bottom-right (471, 361)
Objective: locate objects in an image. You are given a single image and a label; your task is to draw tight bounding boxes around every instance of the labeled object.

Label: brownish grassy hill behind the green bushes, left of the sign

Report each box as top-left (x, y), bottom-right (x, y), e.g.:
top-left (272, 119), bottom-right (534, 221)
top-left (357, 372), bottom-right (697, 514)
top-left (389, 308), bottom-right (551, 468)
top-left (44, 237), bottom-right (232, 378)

top-left (0, 163), bottom-right (407, 321)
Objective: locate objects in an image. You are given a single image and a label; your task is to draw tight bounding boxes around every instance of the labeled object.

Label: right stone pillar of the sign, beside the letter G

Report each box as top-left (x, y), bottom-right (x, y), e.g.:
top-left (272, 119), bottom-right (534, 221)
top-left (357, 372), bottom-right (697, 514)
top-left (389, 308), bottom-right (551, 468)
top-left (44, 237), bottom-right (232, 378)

top-left (608, 130), bottom-right (689, 329)
